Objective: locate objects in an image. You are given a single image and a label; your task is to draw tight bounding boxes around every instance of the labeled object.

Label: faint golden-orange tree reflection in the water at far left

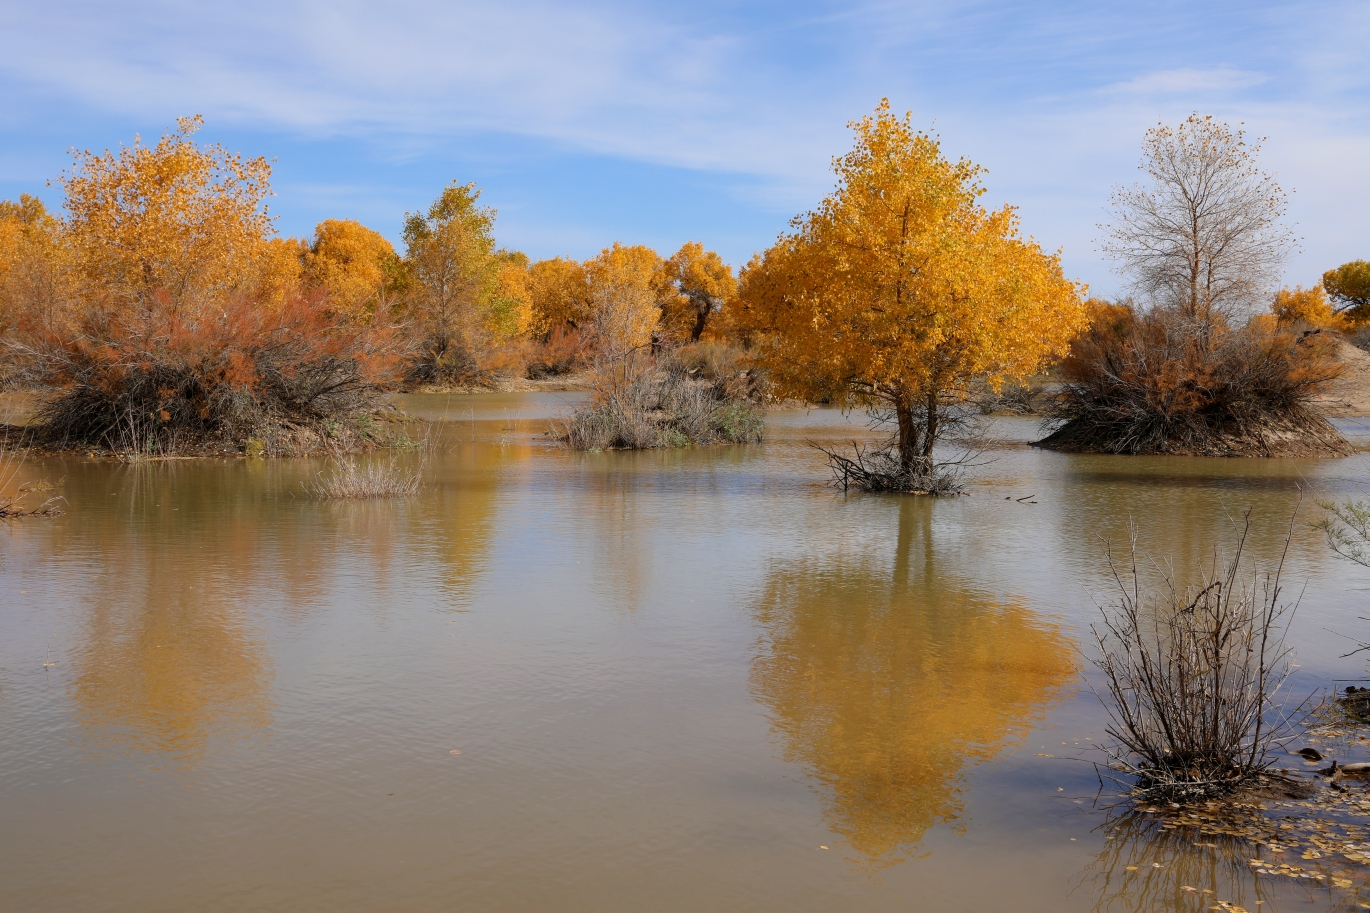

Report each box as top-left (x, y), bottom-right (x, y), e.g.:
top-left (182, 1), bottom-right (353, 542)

top-left (66, 467), bottom-right (271, 764)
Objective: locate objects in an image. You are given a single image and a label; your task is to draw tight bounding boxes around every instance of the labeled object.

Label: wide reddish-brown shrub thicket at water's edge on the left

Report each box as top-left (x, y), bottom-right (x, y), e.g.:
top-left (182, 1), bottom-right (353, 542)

top-left (19, 287), bottom-right (397, 454)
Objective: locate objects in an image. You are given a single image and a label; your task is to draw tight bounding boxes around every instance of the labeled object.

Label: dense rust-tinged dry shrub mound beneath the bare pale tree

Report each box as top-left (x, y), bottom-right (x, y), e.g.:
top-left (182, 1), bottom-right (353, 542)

top-left (1040, 304), bottom-right (1351, 457)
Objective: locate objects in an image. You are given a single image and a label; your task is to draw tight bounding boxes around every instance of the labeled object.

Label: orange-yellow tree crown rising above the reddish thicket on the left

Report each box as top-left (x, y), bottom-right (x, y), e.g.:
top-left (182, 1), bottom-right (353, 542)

top-left (58, 117), bottom-right (274, 311)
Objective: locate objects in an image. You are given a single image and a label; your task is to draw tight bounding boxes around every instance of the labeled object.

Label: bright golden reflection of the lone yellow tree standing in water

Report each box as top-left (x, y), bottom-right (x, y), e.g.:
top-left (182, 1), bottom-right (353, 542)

top-left (752, 499), bottom-right (1073, 868)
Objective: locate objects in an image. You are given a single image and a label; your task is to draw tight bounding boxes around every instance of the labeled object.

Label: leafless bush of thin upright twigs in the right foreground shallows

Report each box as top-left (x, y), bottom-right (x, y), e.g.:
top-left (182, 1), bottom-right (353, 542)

top-left (1091, 513), bottom-right (1295, 802)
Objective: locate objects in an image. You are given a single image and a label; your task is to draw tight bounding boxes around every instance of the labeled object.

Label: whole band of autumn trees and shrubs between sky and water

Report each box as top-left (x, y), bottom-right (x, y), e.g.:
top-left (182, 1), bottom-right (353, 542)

top-left (0, 101), bottom-right (1370, 466)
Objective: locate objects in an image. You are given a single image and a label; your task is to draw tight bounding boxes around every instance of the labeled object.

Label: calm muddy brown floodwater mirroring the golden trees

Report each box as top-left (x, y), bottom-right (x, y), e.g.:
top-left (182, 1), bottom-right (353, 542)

top-left (0, 395), bottom-right (1370, 913)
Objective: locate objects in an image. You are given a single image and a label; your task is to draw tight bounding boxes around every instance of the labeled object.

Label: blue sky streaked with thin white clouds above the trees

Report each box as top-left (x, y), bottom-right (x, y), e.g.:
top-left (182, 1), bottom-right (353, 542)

top-left (0, 0), bottom-right (1370, 293)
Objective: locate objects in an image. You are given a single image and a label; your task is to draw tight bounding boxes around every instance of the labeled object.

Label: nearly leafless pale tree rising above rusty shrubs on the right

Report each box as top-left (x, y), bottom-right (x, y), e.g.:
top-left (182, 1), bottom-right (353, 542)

top-left (1099, 112), bottom-right (1297, 324)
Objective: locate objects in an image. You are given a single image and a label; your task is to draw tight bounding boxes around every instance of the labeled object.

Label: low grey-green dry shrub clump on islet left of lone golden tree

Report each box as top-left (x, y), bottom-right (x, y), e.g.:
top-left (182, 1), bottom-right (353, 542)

top-left (562, 354), bottom-right (766, 450)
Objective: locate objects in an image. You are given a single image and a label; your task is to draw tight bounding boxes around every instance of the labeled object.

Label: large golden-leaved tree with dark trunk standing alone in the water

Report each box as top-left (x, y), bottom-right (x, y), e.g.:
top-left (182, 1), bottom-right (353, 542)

top-left (741, 100), bottom-right (1088, 474)
